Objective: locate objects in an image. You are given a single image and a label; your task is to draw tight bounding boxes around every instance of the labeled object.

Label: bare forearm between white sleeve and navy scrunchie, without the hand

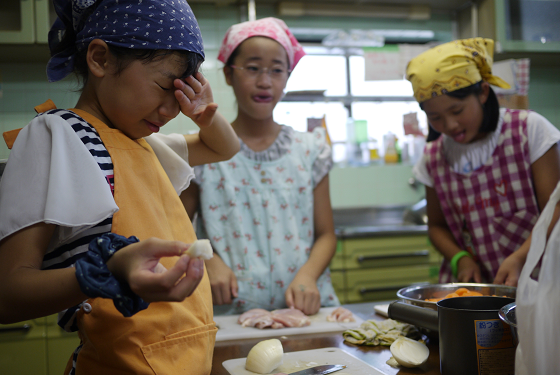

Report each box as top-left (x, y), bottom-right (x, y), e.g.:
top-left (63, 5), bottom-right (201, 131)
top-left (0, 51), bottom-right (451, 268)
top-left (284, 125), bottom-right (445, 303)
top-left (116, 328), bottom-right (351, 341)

top-left (0, 223), bottom-right (87, 324)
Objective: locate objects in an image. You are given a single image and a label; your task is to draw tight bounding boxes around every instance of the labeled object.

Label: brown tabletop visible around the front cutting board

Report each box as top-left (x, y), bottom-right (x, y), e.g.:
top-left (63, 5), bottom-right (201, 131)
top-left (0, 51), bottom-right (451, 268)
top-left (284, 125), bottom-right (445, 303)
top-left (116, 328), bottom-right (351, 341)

top-left (211, 302), bottom-right (440, 375)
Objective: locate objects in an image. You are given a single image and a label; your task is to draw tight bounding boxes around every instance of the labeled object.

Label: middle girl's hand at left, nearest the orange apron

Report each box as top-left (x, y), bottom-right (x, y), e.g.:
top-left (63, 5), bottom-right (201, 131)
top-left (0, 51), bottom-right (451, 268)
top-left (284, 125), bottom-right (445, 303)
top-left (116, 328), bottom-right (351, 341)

top-left (206, 254), bottom-right (238, 305)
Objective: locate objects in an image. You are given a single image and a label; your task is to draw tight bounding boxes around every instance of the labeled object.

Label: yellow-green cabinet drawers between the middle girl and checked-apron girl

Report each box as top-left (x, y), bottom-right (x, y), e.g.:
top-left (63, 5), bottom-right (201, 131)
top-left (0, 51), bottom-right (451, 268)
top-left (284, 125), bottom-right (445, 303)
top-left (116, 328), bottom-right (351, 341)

top-left (330, 233), bottom-right (442, 303)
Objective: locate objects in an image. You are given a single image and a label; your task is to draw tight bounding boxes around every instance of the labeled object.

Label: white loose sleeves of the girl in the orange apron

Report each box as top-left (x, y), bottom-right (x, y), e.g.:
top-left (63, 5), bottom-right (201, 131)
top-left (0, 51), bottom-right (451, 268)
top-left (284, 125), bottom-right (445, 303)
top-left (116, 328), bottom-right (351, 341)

top-left (0, 114), bottom-right (194, 247)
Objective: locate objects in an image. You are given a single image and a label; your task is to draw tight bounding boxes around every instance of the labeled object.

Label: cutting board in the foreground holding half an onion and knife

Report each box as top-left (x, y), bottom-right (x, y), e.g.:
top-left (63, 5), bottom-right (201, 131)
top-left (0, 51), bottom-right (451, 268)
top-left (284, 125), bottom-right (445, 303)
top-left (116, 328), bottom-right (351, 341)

top-left (222, 348), bottom-right (386, 375)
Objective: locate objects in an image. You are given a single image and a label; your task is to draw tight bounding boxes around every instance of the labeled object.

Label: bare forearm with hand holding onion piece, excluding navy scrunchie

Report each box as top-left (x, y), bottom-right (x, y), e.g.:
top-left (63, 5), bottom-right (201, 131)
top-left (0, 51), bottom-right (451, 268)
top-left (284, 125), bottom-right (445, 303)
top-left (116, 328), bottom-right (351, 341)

top-left (0, 223), bottom-right (204, 324)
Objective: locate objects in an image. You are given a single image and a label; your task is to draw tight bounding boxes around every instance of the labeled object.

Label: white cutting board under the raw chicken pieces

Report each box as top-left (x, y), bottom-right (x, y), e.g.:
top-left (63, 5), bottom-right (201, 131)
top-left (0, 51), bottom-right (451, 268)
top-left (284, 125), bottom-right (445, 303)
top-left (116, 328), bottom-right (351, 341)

top-left (214, 307), bottom-right (363, 341)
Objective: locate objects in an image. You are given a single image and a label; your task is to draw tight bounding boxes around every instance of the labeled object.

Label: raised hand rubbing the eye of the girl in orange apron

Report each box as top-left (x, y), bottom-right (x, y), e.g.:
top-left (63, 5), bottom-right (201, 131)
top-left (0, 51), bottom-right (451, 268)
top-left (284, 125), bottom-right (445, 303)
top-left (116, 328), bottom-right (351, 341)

top-left (173, 72), bottom-right (218, 128)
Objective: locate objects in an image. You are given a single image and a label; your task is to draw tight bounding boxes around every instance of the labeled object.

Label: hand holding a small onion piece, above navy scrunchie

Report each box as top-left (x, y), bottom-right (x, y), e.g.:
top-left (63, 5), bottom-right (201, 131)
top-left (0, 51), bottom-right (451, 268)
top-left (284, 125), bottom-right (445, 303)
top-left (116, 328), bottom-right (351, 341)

top-left (107, 238), bottom-right (204, 302)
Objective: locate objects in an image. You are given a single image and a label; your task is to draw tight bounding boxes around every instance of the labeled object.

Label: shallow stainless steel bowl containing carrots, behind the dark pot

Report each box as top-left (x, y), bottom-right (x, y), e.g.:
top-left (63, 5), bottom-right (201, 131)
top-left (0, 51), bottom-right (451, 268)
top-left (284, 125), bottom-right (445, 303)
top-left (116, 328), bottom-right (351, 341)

top-left (397, 283), bottom-right (517, 310)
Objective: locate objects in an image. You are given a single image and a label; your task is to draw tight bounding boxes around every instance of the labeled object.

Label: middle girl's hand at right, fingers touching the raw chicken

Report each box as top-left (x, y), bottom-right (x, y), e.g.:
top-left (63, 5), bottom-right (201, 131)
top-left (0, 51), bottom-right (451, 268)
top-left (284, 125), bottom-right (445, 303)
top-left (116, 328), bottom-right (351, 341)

top-left (285, 272), bottom-right (321, 315)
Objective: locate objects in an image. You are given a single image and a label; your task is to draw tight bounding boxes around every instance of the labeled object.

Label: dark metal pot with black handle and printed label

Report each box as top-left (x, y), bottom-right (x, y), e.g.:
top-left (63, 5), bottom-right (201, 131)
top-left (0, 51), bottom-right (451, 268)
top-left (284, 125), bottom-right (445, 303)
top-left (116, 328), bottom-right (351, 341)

top-left (389, 296), bottom-right (515, 375)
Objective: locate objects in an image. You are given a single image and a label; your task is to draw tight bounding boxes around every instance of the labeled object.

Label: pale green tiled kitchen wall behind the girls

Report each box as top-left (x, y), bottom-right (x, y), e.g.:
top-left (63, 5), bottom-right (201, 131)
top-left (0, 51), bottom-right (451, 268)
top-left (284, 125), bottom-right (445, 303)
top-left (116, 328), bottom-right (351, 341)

top-left (0, 4), bottom-right (560, 208)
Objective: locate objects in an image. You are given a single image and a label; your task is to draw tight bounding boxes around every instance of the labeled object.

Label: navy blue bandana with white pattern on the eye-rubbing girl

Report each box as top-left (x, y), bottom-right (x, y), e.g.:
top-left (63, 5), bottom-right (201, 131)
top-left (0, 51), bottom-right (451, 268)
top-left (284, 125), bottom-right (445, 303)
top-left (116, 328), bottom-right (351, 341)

top-left (47, 0), bottom-right (204, 82)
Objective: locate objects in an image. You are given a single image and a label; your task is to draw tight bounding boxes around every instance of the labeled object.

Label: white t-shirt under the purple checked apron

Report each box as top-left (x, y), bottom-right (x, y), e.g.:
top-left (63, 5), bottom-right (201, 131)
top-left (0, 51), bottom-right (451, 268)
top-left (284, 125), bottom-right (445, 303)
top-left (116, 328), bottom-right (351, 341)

top-left (412, 108), bottom-right (560, 187)
